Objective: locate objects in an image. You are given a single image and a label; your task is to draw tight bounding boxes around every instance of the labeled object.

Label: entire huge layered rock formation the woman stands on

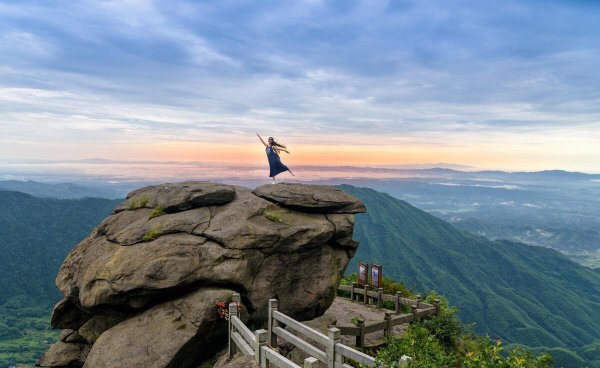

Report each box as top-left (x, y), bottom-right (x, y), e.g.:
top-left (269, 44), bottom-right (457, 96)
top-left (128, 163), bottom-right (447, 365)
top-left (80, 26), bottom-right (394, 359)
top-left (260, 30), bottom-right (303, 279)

top-left (39, 182), bottom-right (365, 368)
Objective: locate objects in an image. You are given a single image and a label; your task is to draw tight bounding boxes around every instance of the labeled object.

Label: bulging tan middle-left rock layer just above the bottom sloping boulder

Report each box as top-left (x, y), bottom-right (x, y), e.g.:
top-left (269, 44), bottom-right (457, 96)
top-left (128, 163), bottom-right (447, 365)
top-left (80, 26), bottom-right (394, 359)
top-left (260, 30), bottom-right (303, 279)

top-left (58, 233), bottom-right (264, 310)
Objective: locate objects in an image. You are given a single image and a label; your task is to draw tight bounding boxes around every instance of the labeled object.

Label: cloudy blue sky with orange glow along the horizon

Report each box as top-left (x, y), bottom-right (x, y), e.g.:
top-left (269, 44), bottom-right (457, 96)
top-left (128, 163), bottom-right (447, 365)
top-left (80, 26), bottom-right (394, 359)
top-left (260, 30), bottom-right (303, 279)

top-left (0, 0), bottom-right (600, 172)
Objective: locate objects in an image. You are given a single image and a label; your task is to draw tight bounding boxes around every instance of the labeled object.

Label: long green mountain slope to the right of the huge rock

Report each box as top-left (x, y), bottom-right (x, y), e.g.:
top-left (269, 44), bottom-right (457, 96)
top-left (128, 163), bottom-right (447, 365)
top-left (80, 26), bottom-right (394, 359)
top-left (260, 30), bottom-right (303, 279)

top-left (340, 185), bottom-right (600, 367)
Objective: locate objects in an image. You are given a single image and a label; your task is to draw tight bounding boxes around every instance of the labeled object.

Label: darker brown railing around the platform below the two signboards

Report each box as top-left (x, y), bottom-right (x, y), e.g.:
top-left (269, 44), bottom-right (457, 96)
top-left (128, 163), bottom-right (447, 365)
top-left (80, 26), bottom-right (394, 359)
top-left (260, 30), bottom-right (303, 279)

top-left (338, 283), bottom-right (440, 348)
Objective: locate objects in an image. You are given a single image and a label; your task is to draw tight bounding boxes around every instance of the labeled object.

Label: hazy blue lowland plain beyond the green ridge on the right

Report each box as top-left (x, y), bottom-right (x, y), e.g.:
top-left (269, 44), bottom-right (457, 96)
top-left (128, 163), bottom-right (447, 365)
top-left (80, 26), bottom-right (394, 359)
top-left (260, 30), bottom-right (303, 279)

top-left (321, 170), bottom-right (600, 268)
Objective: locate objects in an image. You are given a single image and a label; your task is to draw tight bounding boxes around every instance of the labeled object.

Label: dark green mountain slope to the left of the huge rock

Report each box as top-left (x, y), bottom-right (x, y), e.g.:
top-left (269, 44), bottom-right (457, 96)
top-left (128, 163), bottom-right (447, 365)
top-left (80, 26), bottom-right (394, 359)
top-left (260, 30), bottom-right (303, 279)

top-left (0, 190), bottom-right (122, 305)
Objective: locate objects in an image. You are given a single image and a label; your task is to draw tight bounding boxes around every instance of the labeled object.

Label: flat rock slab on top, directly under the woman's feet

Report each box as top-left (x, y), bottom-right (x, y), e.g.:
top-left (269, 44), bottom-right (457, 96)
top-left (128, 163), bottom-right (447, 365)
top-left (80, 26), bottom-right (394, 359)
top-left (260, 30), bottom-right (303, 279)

top-left (253, 183), bottom-right (366, 213)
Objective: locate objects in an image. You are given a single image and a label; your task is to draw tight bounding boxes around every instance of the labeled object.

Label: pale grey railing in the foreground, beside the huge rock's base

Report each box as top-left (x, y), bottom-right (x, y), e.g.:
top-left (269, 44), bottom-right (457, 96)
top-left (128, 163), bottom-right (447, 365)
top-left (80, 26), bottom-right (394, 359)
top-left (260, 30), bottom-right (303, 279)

top-left (228, 295), bottom-right (383, 368)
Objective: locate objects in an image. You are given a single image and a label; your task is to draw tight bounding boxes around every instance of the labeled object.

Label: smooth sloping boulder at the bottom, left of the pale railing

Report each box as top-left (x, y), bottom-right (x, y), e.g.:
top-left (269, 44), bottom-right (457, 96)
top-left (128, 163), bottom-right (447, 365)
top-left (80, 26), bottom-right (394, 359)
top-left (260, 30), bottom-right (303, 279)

top-left (84, 288), bottom-right (241, 368)
